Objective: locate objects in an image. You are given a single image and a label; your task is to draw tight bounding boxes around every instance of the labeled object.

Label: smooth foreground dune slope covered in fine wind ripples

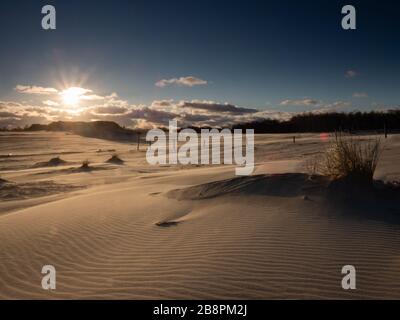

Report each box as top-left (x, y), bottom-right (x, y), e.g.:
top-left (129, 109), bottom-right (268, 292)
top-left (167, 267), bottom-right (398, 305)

top-left (0, 182), bottom-right (400, 299)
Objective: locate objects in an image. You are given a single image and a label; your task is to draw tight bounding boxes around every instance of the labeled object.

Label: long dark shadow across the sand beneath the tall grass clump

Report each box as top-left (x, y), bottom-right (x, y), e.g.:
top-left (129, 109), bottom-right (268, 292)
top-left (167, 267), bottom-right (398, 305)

top-left (167, 173), bottom-right (400, 224)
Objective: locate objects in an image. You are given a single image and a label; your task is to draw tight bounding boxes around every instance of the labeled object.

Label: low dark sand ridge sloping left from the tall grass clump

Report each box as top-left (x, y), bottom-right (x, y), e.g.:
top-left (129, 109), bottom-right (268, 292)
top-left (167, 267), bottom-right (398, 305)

top-left (167, 173), bottom-right (328, 200)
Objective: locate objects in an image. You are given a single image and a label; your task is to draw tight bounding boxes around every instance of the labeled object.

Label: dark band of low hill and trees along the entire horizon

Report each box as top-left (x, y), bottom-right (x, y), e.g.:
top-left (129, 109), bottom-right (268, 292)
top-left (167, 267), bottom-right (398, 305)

top-left (0, 110), bottom-right (400, 136)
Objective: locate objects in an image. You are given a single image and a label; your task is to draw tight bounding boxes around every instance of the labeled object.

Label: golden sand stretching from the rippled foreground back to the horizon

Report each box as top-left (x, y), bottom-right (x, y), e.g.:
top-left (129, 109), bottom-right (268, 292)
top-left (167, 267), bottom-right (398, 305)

top-left (0, 132), bottom-right (400, 299)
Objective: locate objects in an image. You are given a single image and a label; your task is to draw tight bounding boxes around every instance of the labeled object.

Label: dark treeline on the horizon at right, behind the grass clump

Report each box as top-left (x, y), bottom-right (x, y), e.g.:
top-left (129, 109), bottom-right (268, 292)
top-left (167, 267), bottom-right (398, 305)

top-left (232, 110), bottom-right (400, 133)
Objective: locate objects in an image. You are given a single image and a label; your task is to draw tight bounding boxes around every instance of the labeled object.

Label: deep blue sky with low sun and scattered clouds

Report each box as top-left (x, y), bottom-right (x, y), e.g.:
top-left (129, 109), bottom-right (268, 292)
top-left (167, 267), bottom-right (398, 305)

top-left (0, 0), bottom-right (400, 127)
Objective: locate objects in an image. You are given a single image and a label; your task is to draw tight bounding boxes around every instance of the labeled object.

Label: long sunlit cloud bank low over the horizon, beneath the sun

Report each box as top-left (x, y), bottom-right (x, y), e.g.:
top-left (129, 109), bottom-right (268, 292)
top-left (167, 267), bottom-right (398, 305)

top-left (0, 95), bottom-right (294, 129)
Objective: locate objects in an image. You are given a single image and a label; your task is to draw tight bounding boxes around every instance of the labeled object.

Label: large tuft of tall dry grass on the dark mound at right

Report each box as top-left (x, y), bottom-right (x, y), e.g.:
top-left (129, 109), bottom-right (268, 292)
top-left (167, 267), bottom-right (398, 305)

top-left (320, 136), bottom-right (382, 185)
